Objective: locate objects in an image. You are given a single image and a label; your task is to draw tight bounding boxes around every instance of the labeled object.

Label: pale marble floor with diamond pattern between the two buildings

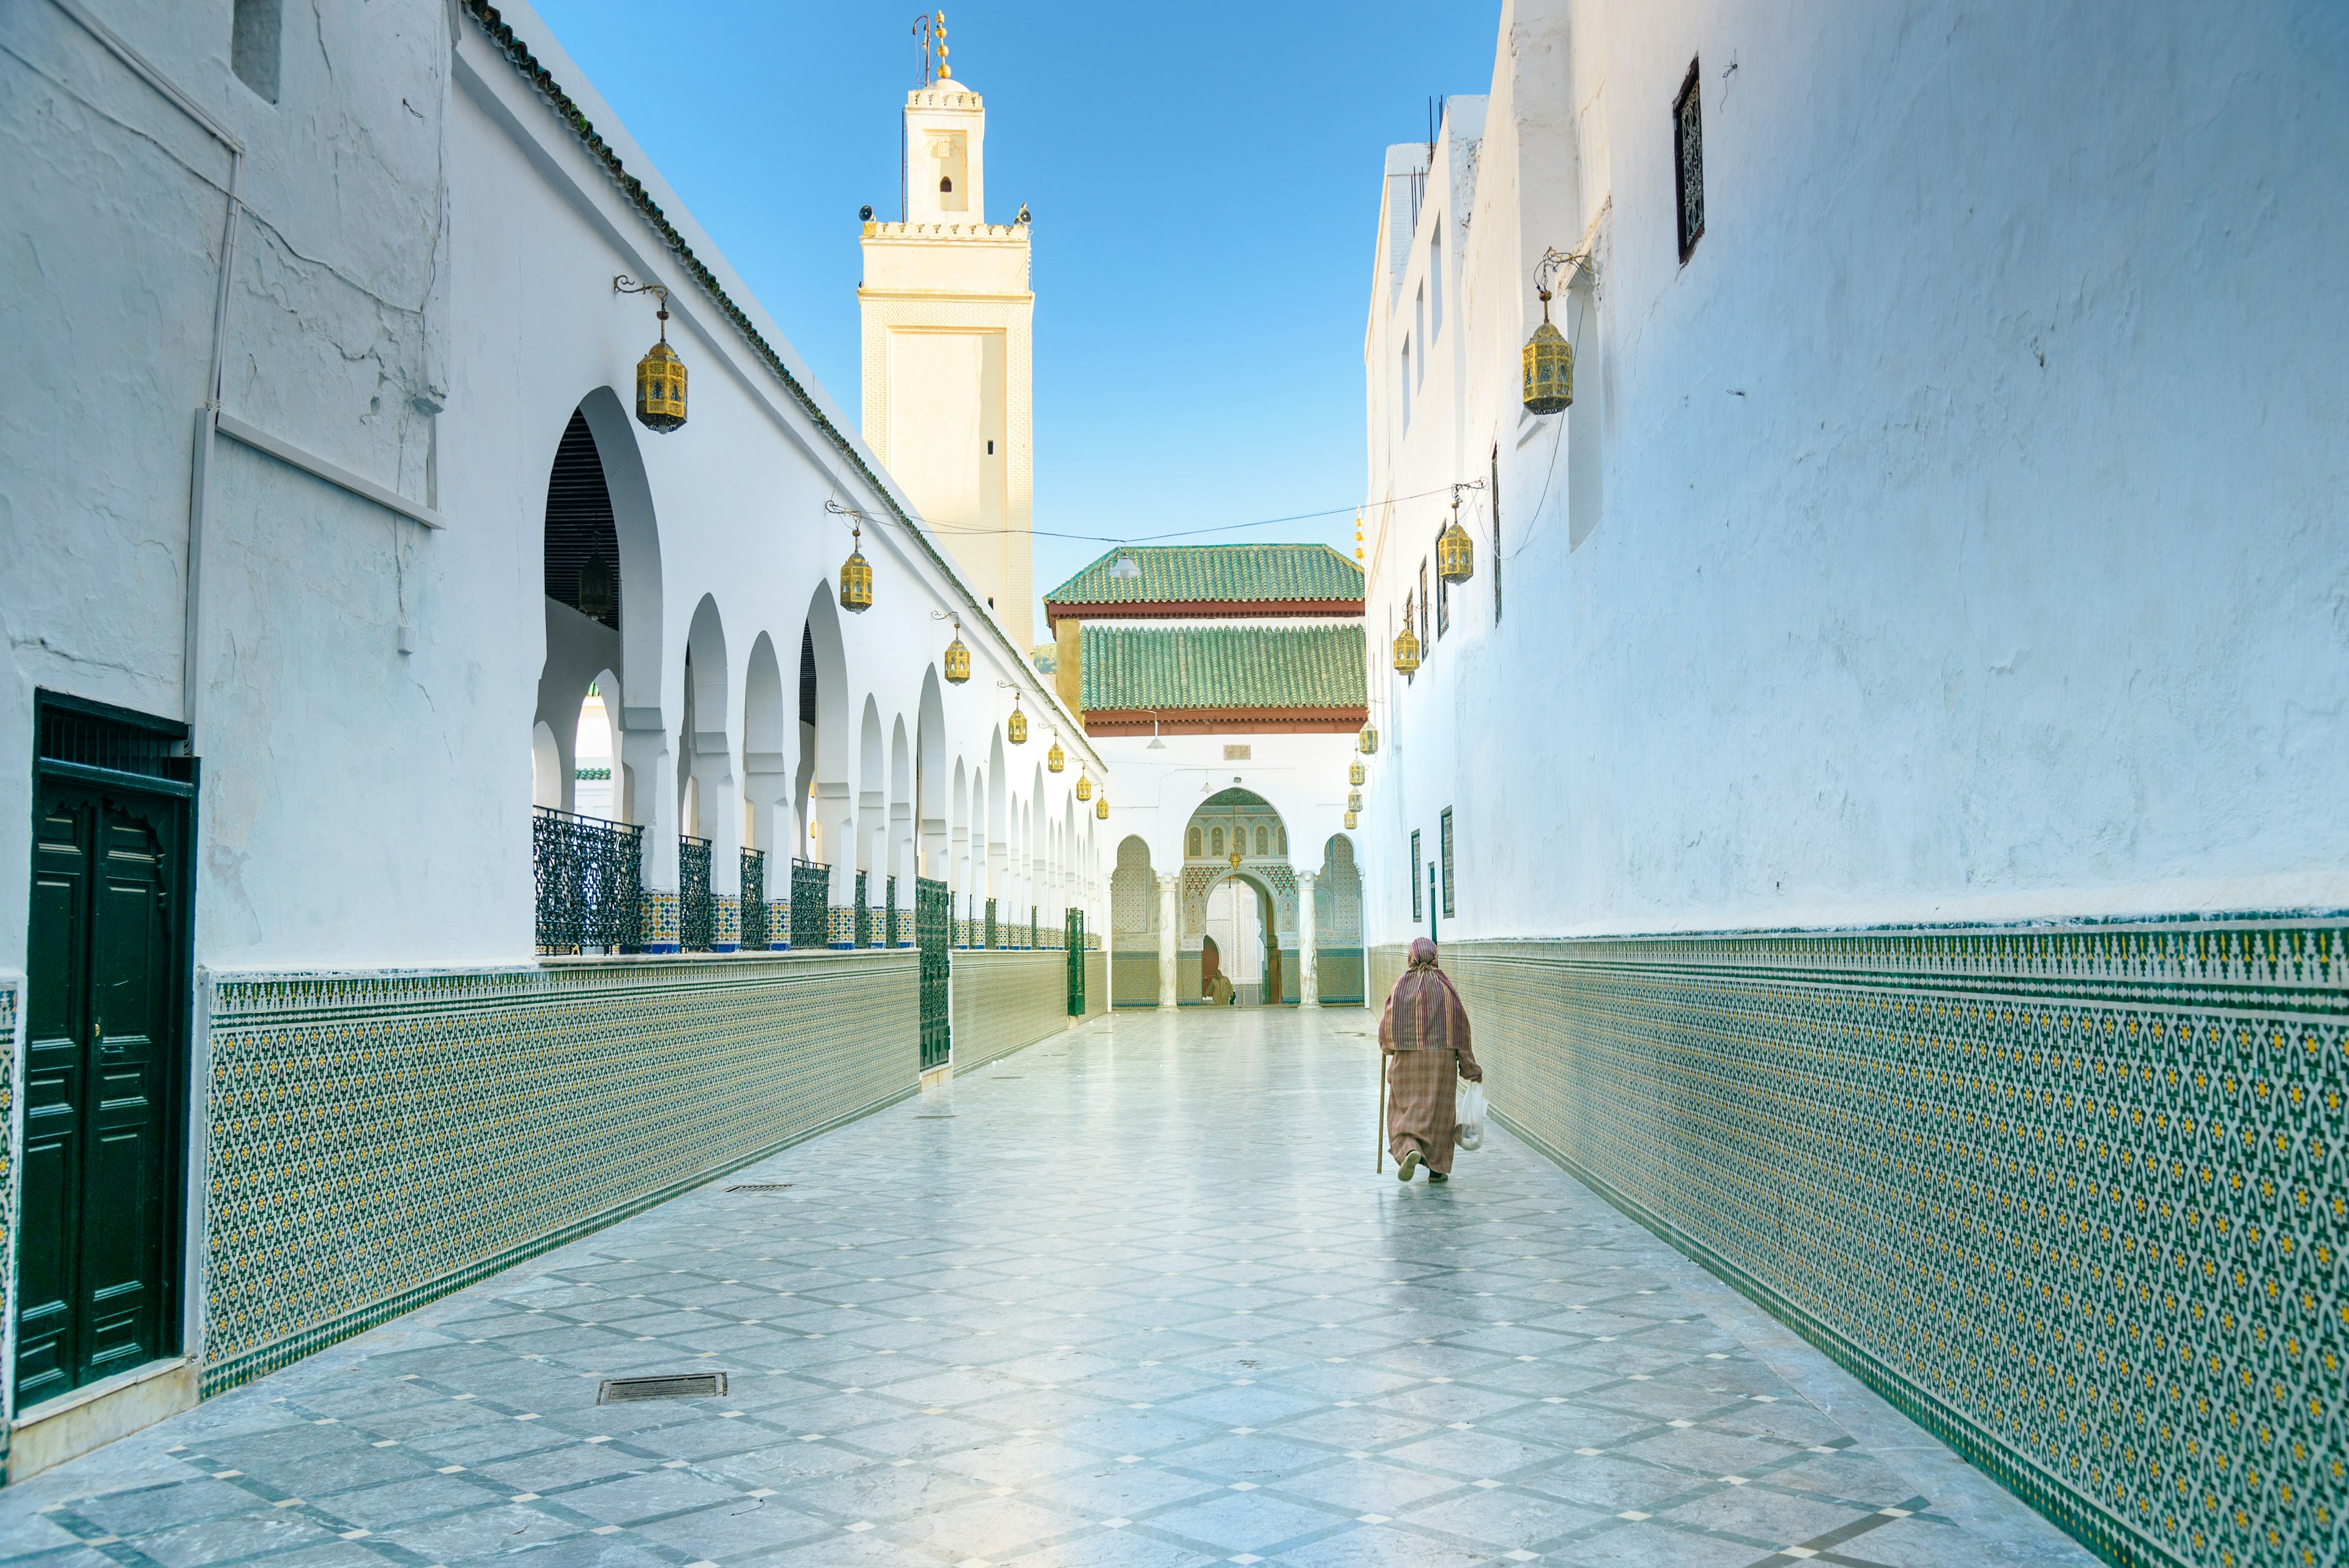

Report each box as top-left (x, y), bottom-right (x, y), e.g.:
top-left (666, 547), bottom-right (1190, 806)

top-left (0, 1011), bottom-right (2091, 1568)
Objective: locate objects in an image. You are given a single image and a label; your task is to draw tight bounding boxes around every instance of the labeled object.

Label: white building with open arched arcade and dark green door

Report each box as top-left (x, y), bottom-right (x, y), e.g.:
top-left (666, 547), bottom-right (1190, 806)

top-left (0, 0), bottom-right (1111, 1474)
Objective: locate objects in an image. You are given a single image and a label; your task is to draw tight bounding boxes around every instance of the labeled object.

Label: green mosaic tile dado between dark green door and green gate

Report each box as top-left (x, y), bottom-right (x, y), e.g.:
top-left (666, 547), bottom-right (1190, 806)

top-left (204, 952), bottom-right (921, 1396)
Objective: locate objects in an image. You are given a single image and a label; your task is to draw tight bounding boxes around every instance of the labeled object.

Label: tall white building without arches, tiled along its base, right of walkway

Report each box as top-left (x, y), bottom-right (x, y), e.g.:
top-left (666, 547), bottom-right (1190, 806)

top-left (1362, 0), bottom-right (2349, 1563)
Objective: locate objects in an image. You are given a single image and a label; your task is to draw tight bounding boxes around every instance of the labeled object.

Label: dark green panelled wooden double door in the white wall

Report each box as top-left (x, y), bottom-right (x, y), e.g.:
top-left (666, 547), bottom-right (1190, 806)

top-left (17, 778), bottom-right (185, 1411)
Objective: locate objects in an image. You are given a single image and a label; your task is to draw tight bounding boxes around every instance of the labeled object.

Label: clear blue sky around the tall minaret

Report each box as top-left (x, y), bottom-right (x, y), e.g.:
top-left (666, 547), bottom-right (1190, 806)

top-left (538, 0), bottom-right (1501, 628)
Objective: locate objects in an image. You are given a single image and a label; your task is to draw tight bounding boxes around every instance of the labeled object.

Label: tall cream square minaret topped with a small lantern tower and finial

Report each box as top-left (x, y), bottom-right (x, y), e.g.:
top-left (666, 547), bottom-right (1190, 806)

top-left (858, 12), bottom-right (1036, 651)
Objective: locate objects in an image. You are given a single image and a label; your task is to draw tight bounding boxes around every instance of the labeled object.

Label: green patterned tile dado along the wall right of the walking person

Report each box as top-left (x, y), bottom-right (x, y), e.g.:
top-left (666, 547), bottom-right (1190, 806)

top-left (1374, 917), bottom-right (2349, 1568)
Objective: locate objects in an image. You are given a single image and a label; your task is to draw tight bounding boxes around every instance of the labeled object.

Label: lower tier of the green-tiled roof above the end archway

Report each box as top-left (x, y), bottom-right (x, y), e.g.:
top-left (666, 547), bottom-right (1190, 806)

top-left (1078, 625), bottom-right (1370, 710)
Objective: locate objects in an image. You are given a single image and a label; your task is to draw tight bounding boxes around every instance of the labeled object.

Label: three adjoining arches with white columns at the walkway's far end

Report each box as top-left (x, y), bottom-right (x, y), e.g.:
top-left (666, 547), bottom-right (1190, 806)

top-left (1108, 787), bottom-right (1362, 1006)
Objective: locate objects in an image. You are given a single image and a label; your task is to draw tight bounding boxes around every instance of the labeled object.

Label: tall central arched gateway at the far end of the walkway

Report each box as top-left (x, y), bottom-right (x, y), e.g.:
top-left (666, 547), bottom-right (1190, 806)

top-left (1174, 787), bottom-right (1301, 1006)
